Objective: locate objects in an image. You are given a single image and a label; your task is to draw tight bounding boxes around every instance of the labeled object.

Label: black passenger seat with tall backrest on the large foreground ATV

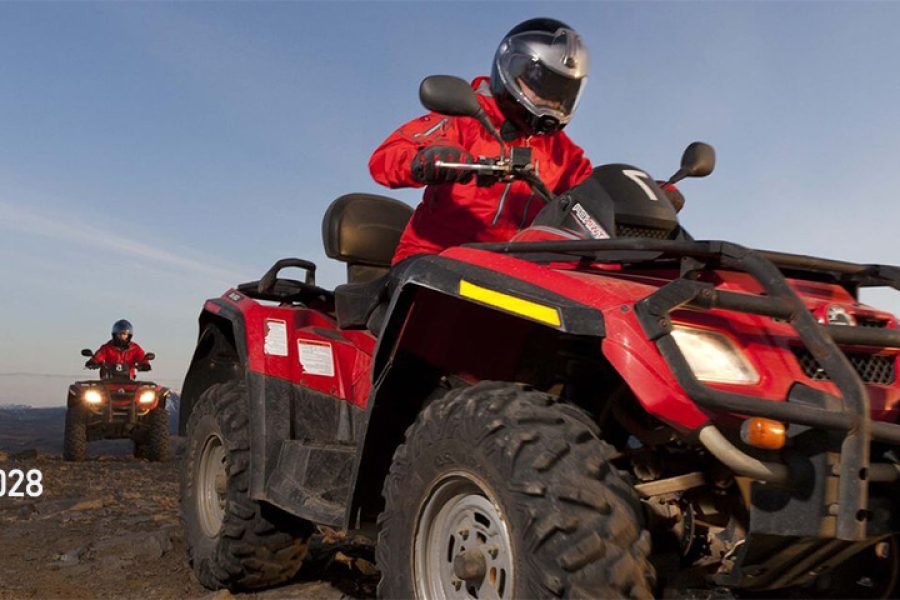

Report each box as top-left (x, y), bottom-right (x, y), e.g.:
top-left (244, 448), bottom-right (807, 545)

top-left (322, 194), bottom-right (413, 333)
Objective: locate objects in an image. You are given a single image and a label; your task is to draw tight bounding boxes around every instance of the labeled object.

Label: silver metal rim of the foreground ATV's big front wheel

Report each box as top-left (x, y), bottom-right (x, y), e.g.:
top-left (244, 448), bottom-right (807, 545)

top-left (413, 472), bottom-right (515, 600)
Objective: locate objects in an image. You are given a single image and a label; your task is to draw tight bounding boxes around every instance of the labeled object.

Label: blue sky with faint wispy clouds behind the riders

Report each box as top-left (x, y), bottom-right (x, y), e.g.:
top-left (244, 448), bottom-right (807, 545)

top-left (0, 2), bottom-right (900, 405)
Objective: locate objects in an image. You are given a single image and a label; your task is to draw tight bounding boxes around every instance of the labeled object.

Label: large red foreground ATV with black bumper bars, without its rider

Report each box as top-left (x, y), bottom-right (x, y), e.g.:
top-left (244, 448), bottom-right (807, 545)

top-left (180, 77), bottom-right (900, 599)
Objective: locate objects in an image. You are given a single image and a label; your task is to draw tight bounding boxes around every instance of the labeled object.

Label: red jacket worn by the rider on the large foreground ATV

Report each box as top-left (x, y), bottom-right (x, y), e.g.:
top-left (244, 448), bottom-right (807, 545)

top-left (369, 77), bottom-right (591, 264)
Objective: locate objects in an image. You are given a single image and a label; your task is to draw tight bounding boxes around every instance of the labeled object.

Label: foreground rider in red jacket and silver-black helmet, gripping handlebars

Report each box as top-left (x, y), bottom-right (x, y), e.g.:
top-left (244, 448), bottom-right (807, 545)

top-left (369, 19), bottom-right (591, 264)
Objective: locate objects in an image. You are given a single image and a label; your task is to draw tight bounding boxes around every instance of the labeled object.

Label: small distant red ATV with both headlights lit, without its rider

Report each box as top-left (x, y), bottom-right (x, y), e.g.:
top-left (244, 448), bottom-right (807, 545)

top-left (63, 349), bottom-right (169, 461)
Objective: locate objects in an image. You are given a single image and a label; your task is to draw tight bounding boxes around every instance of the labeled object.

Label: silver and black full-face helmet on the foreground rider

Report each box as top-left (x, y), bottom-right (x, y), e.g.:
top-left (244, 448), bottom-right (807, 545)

top-left (491, 19), bottom-right (591, 135)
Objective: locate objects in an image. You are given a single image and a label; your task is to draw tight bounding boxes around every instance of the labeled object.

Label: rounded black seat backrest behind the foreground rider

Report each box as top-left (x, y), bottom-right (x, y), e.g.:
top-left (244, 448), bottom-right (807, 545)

top-left (322, 194), bottom-right (413, 283)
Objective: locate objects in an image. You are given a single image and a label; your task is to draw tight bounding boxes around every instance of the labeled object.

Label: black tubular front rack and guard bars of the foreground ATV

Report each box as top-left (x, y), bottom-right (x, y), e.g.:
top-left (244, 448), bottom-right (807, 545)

top-left (467, 239), bottom-right (900, 540)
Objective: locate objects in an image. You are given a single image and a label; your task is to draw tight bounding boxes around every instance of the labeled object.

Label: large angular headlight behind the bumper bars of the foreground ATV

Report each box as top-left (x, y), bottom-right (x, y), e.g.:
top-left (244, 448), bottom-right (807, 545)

top-left (672, 325), bottom-right (759, 384)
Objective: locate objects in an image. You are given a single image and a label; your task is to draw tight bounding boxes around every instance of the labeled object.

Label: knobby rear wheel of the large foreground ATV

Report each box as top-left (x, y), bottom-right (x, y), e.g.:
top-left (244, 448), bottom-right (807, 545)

top-left (181, 381), bottom-right (312, 590)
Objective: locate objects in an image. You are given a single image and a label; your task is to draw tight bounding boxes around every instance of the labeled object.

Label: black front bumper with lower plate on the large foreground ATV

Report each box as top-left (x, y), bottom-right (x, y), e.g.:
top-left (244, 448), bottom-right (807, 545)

top-left (635, 242), bottom-right (900, 541)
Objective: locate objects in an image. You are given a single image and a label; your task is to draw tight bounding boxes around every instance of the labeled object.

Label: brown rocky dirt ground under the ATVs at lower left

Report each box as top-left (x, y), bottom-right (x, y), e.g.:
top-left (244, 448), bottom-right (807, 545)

top-left (0, 452), bottom-right (378, 600)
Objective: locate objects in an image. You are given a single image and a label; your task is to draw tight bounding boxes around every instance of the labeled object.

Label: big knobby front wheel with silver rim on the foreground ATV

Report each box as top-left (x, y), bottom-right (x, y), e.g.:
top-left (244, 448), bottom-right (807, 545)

top-left (376, 382), bottom-right (654, 600)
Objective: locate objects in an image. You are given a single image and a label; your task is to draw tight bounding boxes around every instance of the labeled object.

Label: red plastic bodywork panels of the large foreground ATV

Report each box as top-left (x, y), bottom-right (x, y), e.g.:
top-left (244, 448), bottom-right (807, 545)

top-left (213, 247), bottom-right (900, 432)
